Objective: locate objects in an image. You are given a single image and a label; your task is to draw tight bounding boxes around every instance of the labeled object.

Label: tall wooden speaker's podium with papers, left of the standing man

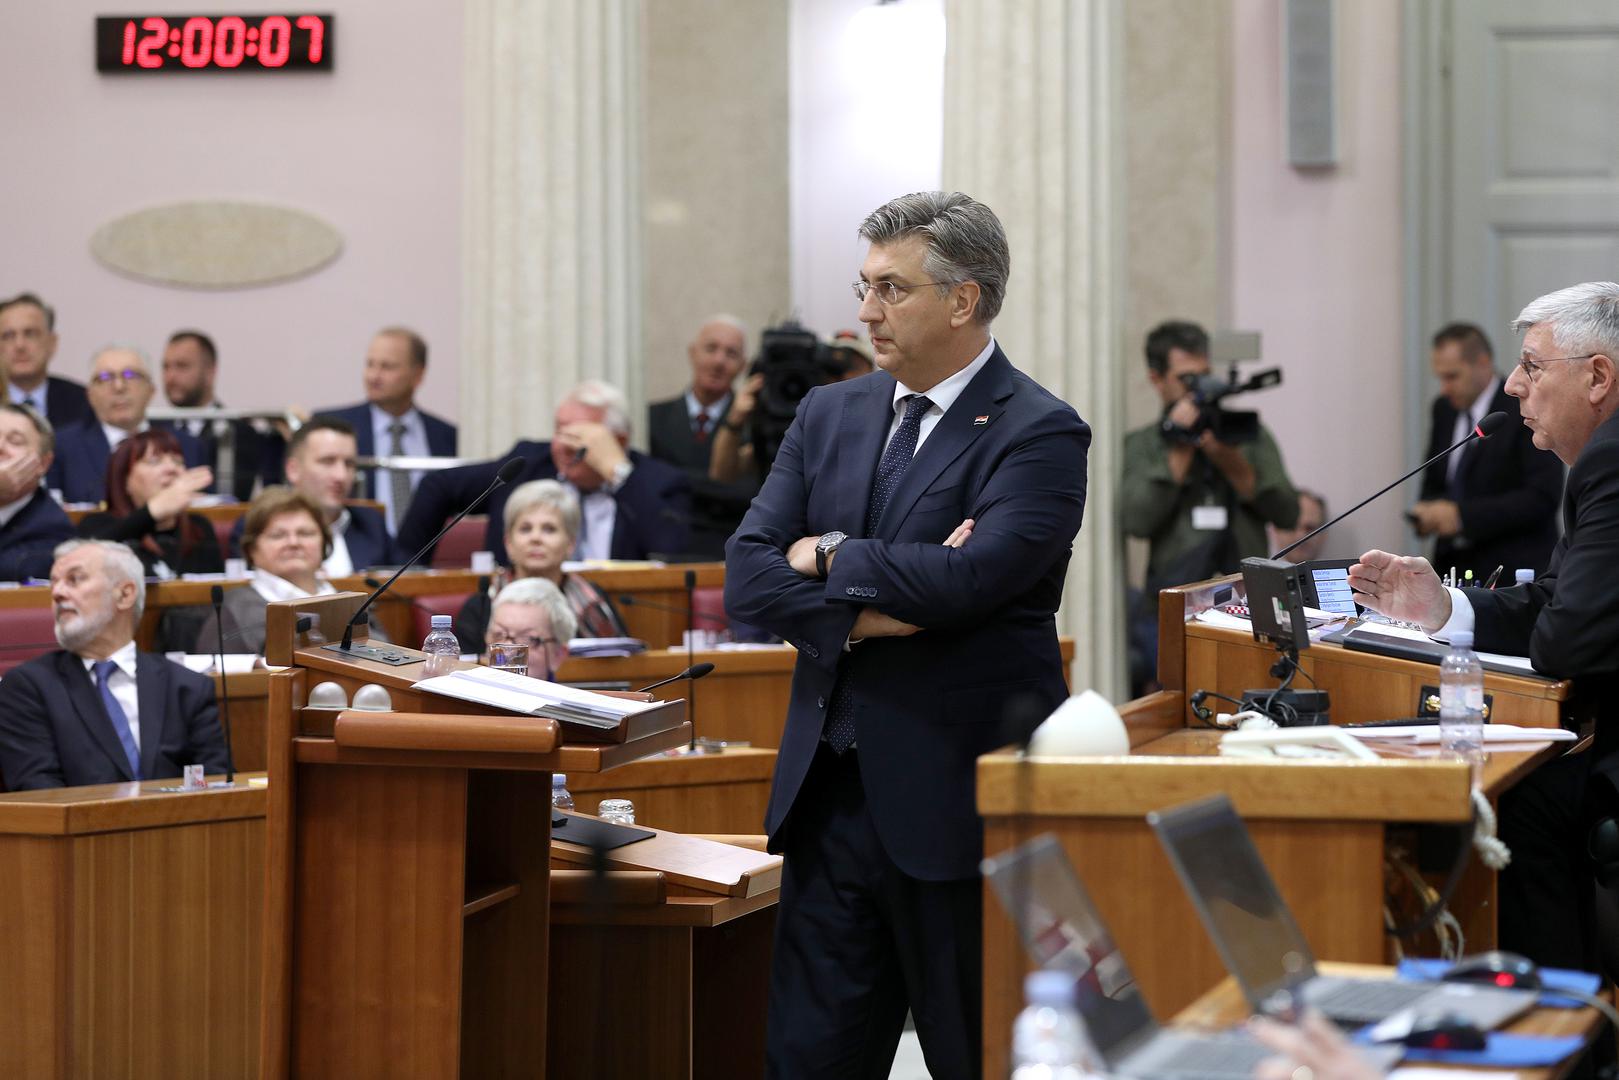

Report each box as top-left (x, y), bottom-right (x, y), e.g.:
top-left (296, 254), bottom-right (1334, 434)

top-left (261, 593), bottom-right (691, 1078)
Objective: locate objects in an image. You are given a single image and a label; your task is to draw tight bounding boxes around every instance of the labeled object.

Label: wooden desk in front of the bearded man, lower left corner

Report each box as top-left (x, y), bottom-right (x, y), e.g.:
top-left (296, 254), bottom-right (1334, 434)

top-left (0, 780), bottom-right (266, 1080)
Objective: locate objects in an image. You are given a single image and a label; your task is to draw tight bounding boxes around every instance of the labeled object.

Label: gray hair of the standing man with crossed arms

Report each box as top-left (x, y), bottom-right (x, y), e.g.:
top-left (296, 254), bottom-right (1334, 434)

top-left (860, 191), bottom-right (1012, 325)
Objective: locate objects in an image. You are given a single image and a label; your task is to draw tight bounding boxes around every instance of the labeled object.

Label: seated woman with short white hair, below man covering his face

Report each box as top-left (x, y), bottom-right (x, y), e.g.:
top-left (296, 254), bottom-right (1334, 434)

top-left (455, 479), bottom-right (630, 653)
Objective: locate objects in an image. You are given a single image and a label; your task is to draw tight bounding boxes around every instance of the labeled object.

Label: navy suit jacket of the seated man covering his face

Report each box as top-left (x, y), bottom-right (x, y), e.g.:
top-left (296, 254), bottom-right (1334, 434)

top-left (398, 442), bottom-right (691, 565)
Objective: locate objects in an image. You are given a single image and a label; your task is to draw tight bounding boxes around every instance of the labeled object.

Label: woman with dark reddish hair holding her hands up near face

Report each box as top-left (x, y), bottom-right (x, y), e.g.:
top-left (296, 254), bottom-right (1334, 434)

top-left (79, 427), bottom-right (225, 578)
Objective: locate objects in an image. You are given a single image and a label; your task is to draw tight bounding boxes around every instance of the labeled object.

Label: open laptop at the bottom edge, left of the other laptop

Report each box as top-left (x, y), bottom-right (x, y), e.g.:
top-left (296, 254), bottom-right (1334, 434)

top-left (983, 834), bottom-right (1399, 1080)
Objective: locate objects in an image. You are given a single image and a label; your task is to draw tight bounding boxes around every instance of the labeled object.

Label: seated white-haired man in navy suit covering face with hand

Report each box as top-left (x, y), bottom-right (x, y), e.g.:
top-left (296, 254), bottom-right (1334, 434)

top-left (398, 379), bottom-right (691, 565)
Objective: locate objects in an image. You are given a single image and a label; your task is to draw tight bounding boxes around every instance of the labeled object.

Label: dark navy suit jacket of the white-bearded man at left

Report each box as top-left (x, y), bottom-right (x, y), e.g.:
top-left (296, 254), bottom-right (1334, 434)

top-left (0, 649), bottom-right (225, 792)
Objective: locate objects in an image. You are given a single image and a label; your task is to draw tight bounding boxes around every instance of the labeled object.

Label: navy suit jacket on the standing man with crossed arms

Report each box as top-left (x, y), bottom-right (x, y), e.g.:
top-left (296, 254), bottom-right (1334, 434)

top-left (725, 348), bottom-right (1091, 881)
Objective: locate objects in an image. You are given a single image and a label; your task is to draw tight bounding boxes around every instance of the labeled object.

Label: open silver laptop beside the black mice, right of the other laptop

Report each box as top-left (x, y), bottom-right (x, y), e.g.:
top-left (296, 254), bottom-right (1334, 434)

top-left (1146, 795), bottom-right (1536, 1030)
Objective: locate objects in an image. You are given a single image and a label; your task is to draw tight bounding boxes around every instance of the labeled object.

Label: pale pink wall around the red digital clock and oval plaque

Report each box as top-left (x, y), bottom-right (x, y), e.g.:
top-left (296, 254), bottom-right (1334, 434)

top-left (0, 0), bottom-right (463, 416)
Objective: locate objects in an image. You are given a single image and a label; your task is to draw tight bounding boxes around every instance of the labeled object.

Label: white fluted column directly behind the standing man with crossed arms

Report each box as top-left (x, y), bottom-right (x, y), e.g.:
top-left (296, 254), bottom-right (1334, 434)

top-left (944, 0), bottom-right (1127, 701)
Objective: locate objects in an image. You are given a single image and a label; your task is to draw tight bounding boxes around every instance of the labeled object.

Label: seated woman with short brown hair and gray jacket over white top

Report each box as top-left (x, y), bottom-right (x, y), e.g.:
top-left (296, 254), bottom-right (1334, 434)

top-left (193, 487), bottom-right (385, 653)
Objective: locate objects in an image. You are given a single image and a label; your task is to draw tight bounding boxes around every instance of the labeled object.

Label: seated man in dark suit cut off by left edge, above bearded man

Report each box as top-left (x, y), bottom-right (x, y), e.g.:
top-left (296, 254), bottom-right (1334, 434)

top-left (0, 402), bottom-right (73, 581)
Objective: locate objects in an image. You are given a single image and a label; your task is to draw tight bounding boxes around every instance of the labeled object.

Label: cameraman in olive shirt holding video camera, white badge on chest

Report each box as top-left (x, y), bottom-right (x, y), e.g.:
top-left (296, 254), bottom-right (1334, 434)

top-left (1119, 322), bottom-right (1298, 595)
